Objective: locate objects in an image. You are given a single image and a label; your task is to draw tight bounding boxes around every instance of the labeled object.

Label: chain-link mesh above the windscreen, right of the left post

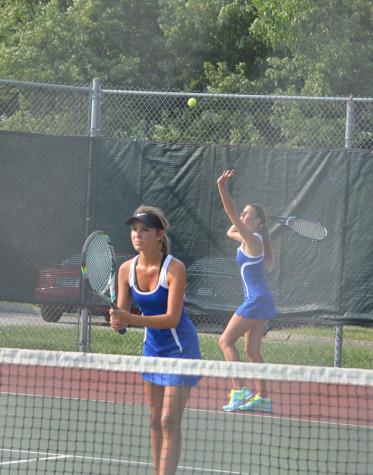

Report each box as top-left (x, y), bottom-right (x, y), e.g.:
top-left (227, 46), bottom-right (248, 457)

top-left (101, 90), bottom-right (373, 149)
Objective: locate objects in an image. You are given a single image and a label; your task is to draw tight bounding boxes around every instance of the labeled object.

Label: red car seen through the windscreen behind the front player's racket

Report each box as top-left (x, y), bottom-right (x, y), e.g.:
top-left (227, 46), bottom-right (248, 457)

top-left (34, 254), bottom-right (133, 322)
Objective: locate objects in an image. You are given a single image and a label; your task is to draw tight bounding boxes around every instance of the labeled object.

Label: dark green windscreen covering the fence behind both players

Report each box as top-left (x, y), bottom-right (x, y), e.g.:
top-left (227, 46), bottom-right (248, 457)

top-left (0, 132), bottom-right (373, 321)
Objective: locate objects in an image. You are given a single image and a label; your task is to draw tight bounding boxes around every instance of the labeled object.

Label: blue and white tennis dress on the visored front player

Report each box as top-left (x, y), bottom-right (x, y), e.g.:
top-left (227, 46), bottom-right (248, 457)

top-left (129, 255), bottom-right (201, 386)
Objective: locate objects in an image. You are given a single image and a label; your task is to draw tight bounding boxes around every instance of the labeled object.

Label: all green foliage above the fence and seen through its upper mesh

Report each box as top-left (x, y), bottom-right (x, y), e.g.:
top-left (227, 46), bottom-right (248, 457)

top-left (0, 0), bottom-right (373, 148)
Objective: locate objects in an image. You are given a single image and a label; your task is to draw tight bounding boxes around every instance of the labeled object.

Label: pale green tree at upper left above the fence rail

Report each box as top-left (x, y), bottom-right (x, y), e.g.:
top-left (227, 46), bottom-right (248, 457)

top-left (0, 0), bottom-right (164, 88)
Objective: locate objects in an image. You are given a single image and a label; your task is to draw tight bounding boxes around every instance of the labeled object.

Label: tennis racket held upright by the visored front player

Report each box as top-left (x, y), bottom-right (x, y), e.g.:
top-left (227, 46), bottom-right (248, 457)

top-left (82, 231), bottom-right (126, 335)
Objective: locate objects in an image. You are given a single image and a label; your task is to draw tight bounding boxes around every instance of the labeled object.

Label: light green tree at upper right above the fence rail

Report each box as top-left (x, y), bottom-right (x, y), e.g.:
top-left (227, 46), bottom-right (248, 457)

top-left (251, 0), bottom-right (373, 96)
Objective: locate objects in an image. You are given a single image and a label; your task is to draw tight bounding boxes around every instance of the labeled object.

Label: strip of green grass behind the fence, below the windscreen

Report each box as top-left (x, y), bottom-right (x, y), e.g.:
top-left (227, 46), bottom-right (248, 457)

top-left (0, 324), bottom-right (373, 369)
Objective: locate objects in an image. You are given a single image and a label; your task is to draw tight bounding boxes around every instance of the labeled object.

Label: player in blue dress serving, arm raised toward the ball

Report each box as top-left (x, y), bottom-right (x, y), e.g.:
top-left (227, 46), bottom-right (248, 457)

top-left (217, 170), bottom-right (276, 412)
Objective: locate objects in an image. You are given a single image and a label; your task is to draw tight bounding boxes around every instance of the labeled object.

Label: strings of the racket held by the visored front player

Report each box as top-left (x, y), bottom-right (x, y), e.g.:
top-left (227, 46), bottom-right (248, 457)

top-left (86, 235), bottom-right (115, 293)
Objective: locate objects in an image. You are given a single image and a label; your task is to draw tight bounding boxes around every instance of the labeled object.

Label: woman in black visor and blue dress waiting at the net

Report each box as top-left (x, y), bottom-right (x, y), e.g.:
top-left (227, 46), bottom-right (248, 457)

top-left (110, 205), bottom-right (201, 475)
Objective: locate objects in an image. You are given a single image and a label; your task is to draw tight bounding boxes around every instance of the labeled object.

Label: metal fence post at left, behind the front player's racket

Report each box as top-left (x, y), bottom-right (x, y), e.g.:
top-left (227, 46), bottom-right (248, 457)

top-left (78, 79), bottom-right (101, 353)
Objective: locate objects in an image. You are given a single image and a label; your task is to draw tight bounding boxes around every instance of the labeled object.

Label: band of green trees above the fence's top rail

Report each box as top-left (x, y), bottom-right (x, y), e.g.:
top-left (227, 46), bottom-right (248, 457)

top-left (0, 0), bottom-right (373, 96)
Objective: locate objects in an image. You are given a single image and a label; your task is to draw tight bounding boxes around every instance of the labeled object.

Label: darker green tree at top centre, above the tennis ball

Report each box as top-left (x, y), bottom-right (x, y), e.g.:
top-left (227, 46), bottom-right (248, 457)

top-left (160, 0), bottom-right (266, 92)
